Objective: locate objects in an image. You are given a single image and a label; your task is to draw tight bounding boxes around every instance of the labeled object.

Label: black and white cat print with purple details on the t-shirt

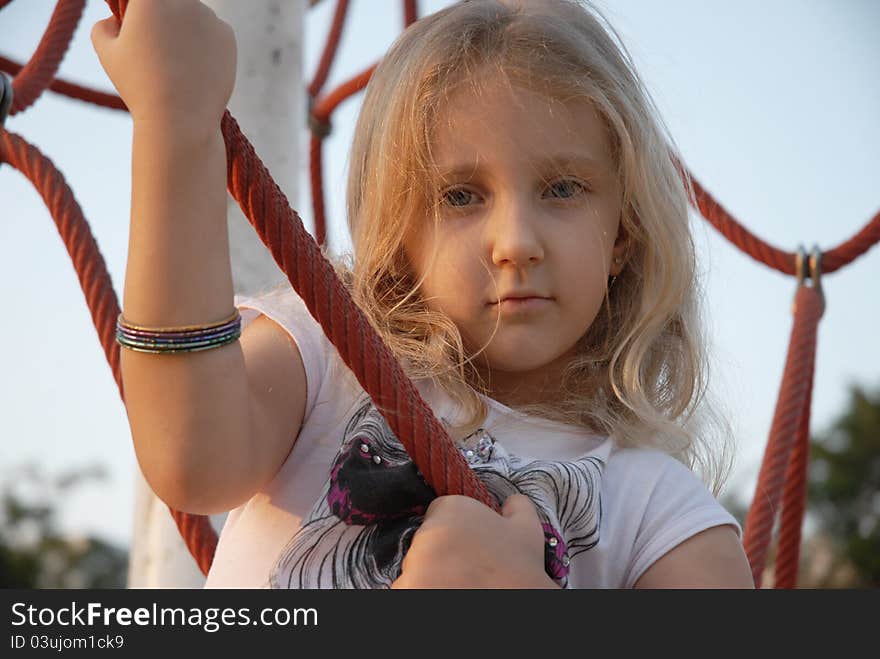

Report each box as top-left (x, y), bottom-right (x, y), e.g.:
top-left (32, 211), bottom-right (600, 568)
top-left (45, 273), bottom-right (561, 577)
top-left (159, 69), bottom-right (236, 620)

top-left (270, 398), bottom-right (602, 588)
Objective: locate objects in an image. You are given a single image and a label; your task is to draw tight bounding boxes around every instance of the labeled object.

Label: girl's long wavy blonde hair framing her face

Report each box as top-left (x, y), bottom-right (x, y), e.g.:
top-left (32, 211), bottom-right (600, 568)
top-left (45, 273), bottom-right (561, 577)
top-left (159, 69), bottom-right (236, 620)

top-left (335, 0), bottom-right (728, 492)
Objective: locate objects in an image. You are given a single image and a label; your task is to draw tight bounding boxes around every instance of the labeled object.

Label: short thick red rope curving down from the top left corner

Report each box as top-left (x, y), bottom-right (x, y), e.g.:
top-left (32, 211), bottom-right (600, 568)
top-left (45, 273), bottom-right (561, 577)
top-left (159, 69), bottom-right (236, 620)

top-left (9, 0), bottom-right (86, 115)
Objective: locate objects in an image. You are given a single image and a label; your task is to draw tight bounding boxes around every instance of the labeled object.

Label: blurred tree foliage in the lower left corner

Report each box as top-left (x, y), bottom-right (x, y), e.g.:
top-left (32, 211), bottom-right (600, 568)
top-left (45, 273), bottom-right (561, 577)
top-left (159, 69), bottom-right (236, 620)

top-left (0, 467), bottom-right (128, 588)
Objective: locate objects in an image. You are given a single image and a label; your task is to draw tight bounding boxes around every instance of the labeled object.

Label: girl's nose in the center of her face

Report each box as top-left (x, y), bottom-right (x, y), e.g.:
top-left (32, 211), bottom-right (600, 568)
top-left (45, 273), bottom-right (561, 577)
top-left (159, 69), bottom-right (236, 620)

top-left (487, 197), bottom-right (544, 267)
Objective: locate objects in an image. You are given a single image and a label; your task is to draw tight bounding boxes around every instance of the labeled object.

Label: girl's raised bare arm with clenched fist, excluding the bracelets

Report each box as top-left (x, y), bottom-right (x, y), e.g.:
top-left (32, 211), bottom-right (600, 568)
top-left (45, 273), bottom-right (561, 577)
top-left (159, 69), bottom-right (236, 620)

top-left (92, 0), bottom-right (305, 513)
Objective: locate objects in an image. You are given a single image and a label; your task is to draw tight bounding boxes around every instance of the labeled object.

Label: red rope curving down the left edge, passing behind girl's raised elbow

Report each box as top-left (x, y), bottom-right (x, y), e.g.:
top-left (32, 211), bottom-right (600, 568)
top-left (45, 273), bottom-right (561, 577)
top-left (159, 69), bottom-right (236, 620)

top-left (0, 129), bottom-right (217, 574)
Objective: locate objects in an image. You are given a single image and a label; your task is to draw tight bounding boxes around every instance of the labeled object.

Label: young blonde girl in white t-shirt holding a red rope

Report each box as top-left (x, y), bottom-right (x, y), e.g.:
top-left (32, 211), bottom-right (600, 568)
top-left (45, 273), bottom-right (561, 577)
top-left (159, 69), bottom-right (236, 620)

top-left (93, 0), bottom-right (752, 588)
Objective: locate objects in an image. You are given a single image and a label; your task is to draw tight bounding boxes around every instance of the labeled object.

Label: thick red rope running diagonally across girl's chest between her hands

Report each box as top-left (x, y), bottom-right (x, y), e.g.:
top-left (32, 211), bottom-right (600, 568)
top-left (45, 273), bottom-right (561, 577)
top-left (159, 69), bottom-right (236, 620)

top-left (222, 111), bottom-right (498, 510)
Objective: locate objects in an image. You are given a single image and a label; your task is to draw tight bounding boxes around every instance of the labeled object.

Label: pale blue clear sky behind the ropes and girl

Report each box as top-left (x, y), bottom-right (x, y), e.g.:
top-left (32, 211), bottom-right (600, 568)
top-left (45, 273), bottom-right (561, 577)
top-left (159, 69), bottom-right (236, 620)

top-left (0, 0), bottom-right (880, 544)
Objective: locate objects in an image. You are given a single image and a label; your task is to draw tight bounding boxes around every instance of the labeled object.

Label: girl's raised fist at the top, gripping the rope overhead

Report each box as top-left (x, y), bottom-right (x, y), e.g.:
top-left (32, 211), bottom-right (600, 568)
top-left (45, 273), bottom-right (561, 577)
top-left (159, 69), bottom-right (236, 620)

top-left (92, 0), bottom-right (236, 136)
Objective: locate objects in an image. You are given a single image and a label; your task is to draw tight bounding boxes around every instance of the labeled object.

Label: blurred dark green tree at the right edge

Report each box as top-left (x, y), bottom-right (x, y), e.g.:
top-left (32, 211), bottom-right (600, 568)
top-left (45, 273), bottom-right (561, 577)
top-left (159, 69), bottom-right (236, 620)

top-left (808, 386), bottom-right (880, 588)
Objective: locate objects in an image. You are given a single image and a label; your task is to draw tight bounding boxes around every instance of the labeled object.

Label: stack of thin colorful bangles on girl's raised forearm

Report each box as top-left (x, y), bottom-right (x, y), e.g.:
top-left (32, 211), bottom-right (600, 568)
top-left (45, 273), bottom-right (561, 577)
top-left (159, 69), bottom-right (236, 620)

top-left (116, 309), bottom-right (241, 353)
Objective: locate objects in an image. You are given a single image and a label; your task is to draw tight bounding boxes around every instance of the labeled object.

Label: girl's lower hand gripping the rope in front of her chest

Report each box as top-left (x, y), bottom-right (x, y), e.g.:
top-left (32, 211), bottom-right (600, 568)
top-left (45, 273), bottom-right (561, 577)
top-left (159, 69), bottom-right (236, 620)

top-left (391, 494), bottom-right (558, 588)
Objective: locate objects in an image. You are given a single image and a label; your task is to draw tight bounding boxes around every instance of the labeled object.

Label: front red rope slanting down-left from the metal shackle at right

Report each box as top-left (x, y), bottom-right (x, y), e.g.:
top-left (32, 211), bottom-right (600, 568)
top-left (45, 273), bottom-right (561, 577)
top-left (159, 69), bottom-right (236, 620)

top-left (743, 286), bottom-right (824, 586)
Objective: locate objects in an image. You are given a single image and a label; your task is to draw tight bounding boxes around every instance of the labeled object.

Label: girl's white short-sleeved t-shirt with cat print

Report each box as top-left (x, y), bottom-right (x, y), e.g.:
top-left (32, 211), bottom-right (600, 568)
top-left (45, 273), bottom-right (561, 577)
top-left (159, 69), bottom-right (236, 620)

top-left (206, 287), bottom-right (741, 588)
